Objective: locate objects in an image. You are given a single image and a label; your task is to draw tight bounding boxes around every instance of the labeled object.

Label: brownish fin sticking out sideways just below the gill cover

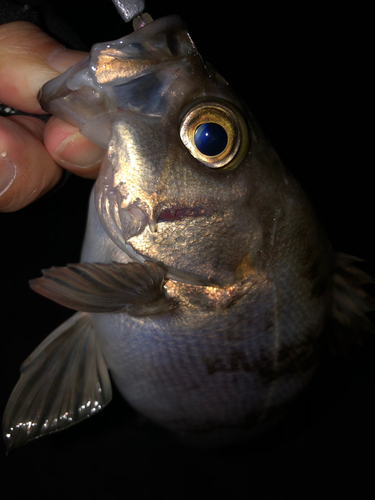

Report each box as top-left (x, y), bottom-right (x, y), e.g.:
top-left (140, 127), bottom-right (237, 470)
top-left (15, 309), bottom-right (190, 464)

top-left (30, 262), bottom-right (169, 316)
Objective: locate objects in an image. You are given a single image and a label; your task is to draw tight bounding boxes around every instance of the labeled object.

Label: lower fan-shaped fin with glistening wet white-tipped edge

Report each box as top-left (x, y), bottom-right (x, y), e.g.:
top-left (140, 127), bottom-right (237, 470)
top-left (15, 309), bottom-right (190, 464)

top-left (3, 313), bottom-right (112, 451)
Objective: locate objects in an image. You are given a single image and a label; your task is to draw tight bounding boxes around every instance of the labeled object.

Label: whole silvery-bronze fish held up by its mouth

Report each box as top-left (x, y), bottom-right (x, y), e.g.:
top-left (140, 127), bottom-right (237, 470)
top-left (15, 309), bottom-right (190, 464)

top-left (4, 0), bottom-right (371, 454)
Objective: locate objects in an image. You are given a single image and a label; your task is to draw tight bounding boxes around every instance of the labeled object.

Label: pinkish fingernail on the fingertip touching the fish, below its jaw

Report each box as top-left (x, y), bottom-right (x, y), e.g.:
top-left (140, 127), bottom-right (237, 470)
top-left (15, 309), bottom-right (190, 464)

top-left (56, 132), bottom-right (104, 168)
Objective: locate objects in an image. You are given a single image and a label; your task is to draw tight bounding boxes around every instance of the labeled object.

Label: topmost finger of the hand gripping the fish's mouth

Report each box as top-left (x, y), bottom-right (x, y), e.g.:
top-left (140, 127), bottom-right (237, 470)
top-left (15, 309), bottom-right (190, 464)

top-left (0, 21), bottom-right (86, 113)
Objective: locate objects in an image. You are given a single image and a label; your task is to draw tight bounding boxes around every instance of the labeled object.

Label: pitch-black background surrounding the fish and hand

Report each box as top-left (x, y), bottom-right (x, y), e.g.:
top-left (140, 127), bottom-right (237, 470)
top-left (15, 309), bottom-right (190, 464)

top-left (0, 0), bottom-right (375, 500)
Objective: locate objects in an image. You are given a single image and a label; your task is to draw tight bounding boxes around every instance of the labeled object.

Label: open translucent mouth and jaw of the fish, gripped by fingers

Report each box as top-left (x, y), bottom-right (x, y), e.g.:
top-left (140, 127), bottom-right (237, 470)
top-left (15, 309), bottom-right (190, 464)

top-left (38, 15), bottom-right (198, 149)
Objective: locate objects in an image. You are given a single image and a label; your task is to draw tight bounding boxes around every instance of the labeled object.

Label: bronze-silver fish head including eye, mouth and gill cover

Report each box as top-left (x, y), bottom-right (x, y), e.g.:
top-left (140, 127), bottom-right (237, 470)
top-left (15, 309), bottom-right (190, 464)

top-left (41, 16), bottom-right (324, 285)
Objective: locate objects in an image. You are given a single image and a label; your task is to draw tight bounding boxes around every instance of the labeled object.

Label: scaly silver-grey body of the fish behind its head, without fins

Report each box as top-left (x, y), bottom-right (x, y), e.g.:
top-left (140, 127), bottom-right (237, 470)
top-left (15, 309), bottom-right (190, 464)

top-left (82, 188), bottom-right (329, 445)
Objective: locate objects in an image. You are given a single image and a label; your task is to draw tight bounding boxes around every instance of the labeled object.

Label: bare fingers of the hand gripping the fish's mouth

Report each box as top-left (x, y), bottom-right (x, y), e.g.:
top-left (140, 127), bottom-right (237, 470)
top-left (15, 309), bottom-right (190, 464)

top-left (0, 22), bottom-right (105, 212)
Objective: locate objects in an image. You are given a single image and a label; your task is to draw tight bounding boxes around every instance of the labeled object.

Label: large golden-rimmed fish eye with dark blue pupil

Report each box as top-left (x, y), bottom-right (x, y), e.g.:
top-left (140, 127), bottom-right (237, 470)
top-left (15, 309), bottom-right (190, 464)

top-left (180, 98), bottom-right (249, 171)
